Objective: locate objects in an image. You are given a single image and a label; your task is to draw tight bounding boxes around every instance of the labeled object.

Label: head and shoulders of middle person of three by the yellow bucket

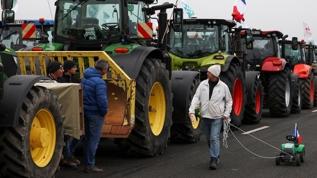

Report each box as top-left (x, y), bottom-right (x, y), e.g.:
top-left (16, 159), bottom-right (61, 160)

top-left (58, 60), bottom-right (80, 83)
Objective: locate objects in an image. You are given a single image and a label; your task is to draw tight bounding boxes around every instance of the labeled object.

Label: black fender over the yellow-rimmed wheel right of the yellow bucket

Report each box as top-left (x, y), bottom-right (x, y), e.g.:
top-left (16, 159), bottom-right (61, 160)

top-left (113, 46), bottom-right (171, 79)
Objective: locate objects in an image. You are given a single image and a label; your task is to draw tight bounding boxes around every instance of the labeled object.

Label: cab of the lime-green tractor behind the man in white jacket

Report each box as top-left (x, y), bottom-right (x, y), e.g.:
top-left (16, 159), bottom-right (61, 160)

top-left (169, 19), bottom-right (235, 59)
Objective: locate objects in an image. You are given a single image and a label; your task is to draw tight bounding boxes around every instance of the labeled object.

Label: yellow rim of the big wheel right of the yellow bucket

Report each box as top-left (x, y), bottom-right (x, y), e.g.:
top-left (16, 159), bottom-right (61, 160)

top-left (149, 82), bottom-right (166, 136)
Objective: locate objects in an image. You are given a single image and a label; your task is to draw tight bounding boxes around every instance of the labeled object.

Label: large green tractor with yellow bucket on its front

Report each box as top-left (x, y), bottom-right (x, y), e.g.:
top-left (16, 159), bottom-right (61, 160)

top-left (18, 0), bottom-right (197, 156)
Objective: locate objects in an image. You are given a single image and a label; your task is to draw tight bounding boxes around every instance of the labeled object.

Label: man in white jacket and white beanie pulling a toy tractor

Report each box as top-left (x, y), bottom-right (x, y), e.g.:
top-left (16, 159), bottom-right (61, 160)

top-left (189, 65), bottom-right (232, 170)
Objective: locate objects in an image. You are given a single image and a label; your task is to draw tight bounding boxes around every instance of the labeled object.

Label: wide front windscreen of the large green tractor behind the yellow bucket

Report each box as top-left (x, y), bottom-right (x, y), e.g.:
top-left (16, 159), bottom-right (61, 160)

top-left (56, 0), bottom-right (121, 40)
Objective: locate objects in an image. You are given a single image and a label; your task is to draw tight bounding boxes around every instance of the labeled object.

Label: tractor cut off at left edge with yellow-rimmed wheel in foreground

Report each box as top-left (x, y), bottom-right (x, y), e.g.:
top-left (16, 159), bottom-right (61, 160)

top-left (0, 0), bottom-right (64, 178)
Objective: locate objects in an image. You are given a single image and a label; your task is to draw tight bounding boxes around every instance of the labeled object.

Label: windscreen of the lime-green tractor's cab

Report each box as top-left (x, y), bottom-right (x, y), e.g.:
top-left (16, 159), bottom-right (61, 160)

top-left (170, 24), bottom-right (219, 58)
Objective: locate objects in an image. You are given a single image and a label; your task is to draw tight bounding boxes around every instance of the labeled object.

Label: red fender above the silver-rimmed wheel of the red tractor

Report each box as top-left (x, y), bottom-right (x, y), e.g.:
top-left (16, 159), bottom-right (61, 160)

top-left (261, 57), bottom-right (287, 72)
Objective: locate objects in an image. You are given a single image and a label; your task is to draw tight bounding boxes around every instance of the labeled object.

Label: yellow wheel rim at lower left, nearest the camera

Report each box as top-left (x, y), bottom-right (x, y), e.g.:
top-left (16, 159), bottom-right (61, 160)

top-left (29, 109), bottom-right (56, 167)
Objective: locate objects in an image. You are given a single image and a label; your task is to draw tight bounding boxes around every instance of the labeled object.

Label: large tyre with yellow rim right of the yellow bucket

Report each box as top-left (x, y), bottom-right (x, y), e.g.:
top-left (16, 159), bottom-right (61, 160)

top-left (121, 58), bottom-right (172, 156)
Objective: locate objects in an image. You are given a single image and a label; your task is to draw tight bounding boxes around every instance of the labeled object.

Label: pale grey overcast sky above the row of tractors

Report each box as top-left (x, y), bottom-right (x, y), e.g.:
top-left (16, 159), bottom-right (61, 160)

top-left (10, 0), bottom-right (317, 42)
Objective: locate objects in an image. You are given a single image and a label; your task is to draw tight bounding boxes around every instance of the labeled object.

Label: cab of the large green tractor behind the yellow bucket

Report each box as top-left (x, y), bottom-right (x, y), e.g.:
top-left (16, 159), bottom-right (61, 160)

top-left (54, 0), bottom-right (164, 51)
